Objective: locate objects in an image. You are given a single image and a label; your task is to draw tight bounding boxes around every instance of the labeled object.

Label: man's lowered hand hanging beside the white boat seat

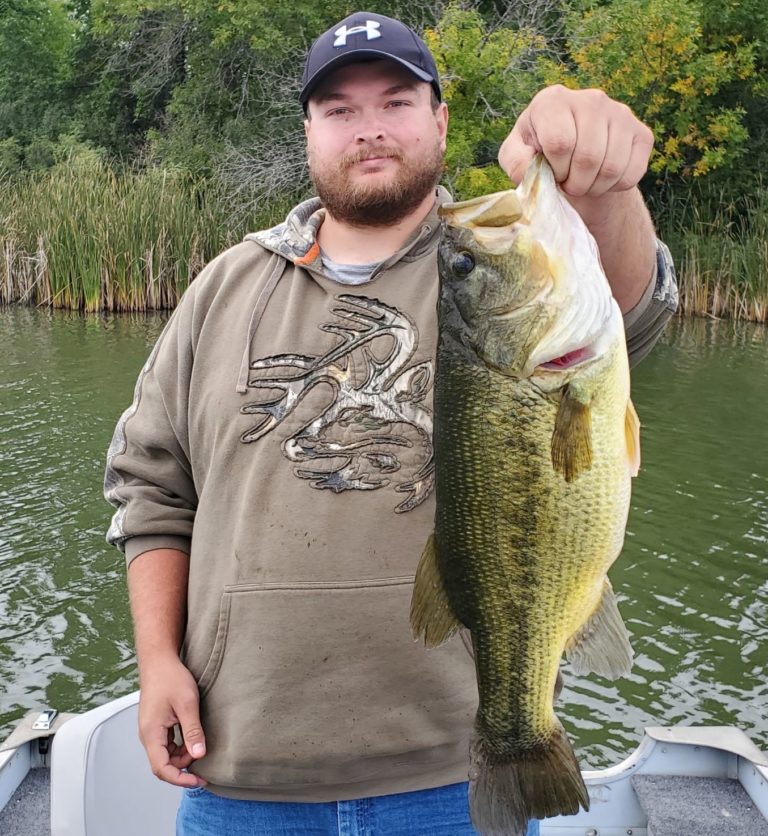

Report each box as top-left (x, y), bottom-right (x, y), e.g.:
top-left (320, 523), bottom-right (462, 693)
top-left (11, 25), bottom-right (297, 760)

top-left (139, 657), bottom-right (205, 787)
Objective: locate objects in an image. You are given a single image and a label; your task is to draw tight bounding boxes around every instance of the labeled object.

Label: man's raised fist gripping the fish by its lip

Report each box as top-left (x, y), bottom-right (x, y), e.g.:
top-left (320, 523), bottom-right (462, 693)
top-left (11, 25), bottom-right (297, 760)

top-left (499, 84), bottom-right (653, 198)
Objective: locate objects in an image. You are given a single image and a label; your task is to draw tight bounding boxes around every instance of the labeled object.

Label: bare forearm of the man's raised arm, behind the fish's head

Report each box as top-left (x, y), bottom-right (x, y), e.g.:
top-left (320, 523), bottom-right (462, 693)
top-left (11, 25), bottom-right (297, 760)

top-left (568, 188), bottom-right (656, 313)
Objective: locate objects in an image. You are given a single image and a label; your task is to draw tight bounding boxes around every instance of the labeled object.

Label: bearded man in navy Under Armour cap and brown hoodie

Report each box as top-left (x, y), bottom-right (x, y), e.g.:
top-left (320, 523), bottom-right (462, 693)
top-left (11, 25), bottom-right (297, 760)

top-left (106, 13), bottom-right (675, 836)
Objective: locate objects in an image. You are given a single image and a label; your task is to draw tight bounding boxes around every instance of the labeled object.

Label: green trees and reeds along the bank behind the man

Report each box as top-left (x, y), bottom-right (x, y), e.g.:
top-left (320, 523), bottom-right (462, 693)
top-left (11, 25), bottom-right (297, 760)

top-left (0, 0), bottom-right (768, 317)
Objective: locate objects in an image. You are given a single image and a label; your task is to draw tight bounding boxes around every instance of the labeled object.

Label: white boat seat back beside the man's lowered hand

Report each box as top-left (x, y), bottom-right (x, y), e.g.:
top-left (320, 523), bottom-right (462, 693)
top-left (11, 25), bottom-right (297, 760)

top-left (51, 691), bottom-right (182, 836)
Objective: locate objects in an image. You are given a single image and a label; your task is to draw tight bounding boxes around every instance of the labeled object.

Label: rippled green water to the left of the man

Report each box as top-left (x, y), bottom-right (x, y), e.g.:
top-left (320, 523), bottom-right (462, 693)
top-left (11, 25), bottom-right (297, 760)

top-left (0, 310), bottom-right (163, 738)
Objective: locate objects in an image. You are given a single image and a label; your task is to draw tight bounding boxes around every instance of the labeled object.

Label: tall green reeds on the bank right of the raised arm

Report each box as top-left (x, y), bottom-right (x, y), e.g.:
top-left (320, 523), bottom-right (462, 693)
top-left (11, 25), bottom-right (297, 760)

top-left (659, 180), bottom-right (768, 323)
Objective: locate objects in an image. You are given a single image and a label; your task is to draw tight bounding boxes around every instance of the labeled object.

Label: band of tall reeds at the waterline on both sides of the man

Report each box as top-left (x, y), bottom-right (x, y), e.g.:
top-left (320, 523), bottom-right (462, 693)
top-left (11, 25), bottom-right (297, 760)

top-left (0, 160), bottom-right (768, 323)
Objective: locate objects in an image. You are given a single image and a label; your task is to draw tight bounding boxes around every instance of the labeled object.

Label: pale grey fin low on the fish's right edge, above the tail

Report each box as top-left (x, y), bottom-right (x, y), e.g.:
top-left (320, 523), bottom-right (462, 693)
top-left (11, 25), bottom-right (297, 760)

top-left (565, 578), bottom-right (634, 679)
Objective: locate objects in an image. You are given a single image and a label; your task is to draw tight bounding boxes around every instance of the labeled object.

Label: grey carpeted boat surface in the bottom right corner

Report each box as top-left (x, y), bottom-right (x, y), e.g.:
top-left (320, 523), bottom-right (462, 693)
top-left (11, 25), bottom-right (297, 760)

top-left (631, 775), bottom-right (768, 836)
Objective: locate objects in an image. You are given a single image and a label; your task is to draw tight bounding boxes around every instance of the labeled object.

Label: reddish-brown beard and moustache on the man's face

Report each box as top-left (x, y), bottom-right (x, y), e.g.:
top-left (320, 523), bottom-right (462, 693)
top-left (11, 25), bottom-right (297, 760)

top-left (309, 143), bottom-right (444, 227)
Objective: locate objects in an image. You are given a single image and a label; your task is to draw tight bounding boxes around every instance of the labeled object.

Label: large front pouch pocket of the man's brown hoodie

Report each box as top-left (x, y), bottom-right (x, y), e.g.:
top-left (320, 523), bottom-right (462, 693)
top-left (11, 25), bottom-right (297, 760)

top-left (195, 577), bottom-right (477, 787)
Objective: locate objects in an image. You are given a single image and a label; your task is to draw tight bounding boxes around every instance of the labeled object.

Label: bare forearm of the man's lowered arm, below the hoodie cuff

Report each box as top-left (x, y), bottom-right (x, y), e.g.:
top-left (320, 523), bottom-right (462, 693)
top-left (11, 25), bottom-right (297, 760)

top-left (128, 549), bottom-right (189, 676)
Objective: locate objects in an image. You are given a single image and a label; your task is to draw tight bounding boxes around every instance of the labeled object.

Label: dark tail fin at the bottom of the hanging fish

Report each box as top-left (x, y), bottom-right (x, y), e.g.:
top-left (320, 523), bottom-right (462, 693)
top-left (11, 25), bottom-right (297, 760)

top-left (469, 721), bottom-right (589, 836)
